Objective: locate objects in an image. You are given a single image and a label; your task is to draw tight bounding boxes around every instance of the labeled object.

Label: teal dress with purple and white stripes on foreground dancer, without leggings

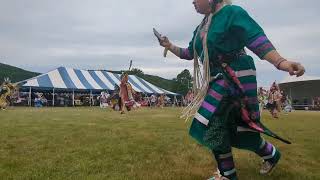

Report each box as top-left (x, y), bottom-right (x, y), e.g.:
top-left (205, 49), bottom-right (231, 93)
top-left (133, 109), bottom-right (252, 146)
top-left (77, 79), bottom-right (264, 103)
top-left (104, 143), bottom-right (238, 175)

top-left (180, 5), bottom-right (287, 150)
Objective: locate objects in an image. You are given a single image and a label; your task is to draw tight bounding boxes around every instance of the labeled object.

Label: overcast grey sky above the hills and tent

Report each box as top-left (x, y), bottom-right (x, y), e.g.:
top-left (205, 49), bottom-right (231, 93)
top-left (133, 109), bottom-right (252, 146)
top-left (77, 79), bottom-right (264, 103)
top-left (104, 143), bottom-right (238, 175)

top-left (0, 0), bottom-right (320, 86)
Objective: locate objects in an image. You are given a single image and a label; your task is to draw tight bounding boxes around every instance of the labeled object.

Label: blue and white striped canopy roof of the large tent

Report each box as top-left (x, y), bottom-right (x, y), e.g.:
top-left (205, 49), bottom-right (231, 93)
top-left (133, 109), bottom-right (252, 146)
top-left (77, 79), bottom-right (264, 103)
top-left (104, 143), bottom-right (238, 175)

top-left (22, 67), bottom-right (178, 95)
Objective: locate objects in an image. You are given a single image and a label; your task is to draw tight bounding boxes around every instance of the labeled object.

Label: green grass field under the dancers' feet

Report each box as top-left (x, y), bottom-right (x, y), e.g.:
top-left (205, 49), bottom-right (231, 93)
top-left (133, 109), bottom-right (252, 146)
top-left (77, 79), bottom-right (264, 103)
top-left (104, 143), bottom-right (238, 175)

top-left (0, 108), bottom-right (320, 180)
